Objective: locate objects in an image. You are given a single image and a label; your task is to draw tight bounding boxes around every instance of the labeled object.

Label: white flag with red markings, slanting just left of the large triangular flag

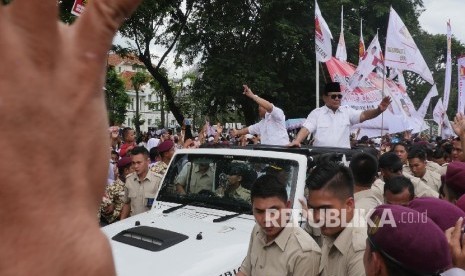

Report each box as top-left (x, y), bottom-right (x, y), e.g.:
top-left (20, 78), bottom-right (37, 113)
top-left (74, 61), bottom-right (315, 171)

top-left (349, 35), bottom-right (383, 91)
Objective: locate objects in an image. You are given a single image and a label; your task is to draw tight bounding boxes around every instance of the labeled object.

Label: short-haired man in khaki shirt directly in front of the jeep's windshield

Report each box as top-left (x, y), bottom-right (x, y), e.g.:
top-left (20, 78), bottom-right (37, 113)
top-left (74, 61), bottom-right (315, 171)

top-left (236, 175), bottom-right (321, 276)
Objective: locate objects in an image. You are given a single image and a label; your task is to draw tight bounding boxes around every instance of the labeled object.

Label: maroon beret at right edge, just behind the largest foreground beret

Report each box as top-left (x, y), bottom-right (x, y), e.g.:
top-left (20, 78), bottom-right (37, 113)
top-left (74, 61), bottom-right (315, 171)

top-left (408, 197), bottom-right (465, 231)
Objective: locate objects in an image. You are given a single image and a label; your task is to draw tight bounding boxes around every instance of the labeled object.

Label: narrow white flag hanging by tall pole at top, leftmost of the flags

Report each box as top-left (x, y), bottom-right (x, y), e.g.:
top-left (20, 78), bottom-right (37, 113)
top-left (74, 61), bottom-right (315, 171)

top-left (315, 1), bottom-right (333, 62)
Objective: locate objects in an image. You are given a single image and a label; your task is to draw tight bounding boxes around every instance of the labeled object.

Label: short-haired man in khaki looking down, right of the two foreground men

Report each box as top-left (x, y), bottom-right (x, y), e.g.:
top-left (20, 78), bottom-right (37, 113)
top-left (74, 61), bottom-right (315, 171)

top-left (307, 162), bottom-right (366, 276)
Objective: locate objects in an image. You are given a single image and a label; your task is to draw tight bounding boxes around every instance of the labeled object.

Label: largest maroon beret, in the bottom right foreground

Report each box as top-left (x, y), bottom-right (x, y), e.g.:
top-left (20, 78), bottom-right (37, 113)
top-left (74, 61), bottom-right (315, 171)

top-left (368, 205), bottom-right (452, 274)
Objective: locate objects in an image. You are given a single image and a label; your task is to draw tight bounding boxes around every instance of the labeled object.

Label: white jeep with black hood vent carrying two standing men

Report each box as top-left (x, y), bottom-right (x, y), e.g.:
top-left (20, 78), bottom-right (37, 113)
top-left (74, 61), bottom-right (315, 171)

top-left (102, 148), bottom-right (356, 276)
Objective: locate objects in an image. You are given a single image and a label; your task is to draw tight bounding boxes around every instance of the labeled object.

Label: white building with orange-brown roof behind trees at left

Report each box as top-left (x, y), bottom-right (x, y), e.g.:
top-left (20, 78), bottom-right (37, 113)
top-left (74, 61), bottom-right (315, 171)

top-left (108, 54), bottom-right (177, 131)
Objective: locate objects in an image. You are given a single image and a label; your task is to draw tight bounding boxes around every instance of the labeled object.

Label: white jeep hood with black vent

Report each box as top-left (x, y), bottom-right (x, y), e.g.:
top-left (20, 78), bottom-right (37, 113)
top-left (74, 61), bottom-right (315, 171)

top-left (102, 205), bottom-right (254, 276)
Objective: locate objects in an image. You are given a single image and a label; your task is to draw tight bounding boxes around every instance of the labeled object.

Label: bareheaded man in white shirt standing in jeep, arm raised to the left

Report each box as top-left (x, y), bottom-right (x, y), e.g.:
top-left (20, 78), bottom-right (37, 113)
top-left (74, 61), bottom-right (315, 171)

top-left (232, 84), bottom-right (289, 146)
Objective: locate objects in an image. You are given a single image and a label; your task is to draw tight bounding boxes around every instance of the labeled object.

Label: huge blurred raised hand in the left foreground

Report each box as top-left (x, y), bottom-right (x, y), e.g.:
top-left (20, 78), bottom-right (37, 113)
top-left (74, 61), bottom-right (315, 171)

top-left (0, 0), bottom-right (140, 275)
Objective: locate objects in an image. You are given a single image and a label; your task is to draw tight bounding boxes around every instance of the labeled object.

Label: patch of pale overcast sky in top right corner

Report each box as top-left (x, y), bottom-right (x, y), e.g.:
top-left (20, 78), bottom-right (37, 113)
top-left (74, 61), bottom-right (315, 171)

top-left (419, 0), bottom-right (465, 43)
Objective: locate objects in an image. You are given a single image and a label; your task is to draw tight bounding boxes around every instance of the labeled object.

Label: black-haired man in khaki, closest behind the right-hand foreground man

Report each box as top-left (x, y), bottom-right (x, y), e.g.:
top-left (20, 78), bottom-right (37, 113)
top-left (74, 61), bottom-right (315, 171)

top-left (349, 152), bottom-right (382, 214)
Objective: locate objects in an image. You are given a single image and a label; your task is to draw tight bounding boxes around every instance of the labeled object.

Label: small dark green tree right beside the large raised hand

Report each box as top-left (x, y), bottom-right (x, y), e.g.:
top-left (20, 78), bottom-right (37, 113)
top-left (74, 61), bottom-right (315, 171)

top-left (105, 66), bottom-right (130, 125)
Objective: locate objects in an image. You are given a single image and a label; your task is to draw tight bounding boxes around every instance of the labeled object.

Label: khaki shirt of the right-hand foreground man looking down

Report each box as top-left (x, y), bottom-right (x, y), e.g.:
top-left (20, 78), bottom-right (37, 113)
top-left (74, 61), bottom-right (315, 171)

top-left (319, 218), bottom-right (367, 276)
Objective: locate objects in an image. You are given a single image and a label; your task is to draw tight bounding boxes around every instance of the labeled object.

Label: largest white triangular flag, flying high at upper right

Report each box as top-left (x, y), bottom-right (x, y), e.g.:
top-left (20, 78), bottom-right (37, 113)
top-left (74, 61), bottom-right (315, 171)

top-left (385, 7), bottom-right (434, 84)
